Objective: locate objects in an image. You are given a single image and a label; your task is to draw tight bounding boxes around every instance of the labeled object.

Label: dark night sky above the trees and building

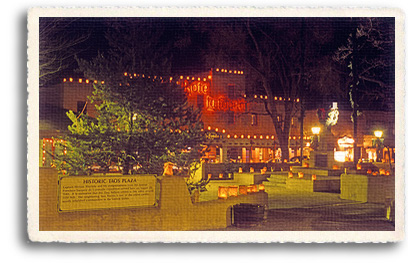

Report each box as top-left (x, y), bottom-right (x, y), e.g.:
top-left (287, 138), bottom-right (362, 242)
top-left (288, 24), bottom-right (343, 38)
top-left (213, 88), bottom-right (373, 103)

top-left (40, 17), bottom-right (394, 110)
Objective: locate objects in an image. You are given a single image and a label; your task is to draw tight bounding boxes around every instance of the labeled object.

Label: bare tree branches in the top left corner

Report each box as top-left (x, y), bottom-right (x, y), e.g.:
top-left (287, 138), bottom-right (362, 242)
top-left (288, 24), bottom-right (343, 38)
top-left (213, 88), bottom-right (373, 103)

top-left (39, 18), bottom-right (89, 86)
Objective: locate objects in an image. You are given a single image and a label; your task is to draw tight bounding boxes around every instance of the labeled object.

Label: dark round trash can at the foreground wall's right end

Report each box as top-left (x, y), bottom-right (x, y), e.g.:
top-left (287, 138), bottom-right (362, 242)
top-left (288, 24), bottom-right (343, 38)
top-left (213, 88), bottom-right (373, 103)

top-left (232, 203), bottom-right (265, 227)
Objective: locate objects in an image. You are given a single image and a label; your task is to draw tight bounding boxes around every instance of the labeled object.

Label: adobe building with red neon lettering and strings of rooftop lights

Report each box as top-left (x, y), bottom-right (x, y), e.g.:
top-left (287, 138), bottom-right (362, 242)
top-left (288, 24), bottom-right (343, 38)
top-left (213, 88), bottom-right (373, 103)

top-left (40, 68), bottom-right (395, 166)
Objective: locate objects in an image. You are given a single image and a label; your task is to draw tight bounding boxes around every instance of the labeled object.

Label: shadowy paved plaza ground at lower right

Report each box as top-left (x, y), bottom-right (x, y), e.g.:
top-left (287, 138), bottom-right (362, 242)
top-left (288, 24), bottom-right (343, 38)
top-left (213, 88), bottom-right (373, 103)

top-left (207, 187), bottom-right (395, 231)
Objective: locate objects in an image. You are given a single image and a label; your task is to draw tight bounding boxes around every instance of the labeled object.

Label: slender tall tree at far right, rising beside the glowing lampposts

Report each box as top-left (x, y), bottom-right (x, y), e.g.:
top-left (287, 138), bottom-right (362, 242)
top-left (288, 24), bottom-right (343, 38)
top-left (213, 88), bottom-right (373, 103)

top-left (334, 18), bottom-right (394, 163)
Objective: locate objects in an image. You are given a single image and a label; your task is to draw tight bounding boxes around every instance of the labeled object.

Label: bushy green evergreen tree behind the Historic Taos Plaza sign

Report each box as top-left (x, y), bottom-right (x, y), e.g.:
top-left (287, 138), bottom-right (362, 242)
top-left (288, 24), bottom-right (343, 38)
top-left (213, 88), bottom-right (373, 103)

top-left (55, 19), bottom-right (204, 174)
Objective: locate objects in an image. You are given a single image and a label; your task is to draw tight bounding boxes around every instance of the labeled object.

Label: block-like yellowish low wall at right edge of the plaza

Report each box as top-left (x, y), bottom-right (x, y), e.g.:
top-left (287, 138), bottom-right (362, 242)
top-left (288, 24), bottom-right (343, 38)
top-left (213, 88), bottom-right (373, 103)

top-left (340, 174), bottom-right (395, 203)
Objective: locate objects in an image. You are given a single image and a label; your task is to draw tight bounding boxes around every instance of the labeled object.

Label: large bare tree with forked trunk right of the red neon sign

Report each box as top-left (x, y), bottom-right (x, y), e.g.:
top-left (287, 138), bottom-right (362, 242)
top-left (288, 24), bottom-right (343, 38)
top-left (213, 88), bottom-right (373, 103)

top-left (209, 18), bottom-right (340, 159)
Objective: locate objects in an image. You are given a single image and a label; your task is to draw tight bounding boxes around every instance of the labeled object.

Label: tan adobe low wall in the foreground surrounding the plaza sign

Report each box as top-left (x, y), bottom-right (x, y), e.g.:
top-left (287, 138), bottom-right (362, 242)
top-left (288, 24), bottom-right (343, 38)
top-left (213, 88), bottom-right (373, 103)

top-left (39, 168), bottom-right (268, 231)
